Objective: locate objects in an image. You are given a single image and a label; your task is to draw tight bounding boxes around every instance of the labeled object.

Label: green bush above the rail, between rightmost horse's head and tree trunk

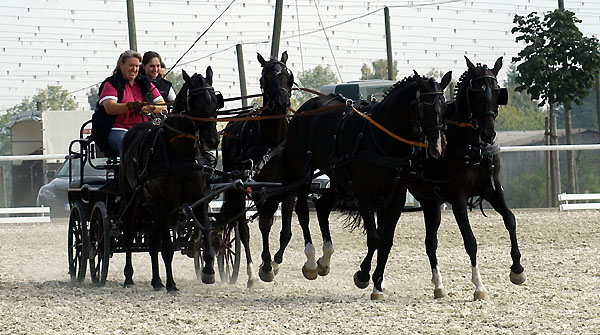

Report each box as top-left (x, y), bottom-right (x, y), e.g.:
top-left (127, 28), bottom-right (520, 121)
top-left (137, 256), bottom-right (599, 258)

top-left (496, 63), bottom-right (546, 130)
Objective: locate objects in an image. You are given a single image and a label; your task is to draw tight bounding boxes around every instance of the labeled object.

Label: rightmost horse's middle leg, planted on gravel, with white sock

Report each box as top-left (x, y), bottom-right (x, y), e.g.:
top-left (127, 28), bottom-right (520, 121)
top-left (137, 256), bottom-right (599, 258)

top-left (452, 200), bottom-right (489, 300)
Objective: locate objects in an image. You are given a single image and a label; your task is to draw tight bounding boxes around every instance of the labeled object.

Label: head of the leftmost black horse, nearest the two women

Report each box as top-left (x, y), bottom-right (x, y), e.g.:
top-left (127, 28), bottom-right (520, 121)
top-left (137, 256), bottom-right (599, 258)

top-left (174, 66), bottom-right (223, 150)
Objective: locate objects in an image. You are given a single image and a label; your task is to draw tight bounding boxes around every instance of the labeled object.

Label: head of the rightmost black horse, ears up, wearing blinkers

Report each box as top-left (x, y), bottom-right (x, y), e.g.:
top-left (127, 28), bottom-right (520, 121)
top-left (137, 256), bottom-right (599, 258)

top-left (458, 56), bottom-right (508, 144)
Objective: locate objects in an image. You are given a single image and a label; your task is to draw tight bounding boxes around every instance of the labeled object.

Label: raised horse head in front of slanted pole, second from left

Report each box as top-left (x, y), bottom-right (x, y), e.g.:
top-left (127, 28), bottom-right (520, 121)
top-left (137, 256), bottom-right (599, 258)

top-left (257, 51), bottom-right (294, 114)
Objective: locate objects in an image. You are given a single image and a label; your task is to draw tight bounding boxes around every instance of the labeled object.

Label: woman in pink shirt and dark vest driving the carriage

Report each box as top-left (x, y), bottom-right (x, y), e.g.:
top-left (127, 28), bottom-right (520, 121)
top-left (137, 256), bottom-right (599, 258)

top-left (99, 50), bottom-right (164, 153)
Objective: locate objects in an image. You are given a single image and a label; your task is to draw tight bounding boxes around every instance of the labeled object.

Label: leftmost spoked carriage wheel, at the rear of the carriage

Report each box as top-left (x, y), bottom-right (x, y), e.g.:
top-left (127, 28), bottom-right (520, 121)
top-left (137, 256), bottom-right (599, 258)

top-left (67, 202), bottom-right (90, 282)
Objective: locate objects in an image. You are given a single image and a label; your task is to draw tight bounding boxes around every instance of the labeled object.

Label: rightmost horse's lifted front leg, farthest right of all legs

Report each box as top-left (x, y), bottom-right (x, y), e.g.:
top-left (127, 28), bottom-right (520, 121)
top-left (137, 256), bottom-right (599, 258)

top-left (488, 185), bottom-right (527, 285)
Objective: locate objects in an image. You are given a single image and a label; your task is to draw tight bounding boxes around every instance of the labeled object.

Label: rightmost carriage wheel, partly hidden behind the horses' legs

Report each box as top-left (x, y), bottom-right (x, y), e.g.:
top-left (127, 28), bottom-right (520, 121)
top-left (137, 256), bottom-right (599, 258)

top-left (217, 224), bottom-right (241, 284)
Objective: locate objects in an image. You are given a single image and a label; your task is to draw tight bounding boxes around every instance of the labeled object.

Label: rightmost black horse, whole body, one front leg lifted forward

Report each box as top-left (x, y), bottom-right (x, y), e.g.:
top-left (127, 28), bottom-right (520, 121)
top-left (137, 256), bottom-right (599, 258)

top-left (409, 57), bottom-right (526, 299)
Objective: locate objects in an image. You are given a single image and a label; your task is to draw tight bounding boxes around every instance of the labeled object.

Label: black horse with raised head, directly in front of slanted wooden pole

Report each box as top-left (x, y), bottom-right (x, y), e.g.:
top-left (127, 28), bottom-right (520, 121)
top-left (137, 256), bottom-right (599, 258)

top-left (221, 52), bottom-right (294, 287)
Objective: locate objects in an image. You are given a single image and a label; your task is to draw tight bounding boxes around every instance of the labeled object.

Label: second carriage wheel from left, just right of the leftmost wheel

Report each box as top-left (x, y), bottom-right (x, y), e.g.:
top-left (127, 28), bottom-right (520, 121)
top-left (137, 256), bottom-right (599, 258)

top-left (89, 201), bottom-right (111, 286)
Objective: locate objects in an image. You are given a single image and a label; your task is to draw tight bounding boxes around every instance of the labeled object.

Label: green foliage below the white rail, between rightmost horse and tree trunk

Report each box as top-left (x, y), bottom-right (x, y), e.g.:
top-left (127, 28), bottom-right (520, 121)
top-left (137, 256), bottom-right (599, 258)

top-left (504, 168), bottom-right (546, 208)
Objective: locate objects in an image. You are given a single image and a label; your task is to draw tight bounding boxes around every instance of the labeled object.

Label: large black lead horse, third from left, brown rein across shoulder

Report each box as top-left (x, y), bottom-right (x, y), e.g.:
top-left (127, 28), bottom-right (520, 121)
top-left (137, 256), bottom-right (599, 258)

top-left (283, 72), bottom-right (451, 299)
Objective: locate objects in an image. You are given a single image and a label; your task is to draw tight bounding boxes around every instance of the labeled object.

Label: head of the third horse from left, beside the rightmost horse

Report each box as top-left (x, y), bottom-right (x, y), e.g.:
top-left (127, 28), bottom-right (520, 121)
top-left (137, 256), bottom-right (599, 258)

top-left (413, 71), bottom-right (452, 158)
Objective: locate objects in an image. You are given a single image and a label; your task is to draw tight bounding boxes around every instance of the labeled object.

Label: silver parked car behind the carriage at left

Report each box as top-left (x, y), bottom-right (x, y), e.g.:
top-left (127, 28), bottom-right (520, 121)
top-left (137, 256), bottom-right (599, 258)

top-left (37, 158), bottom-right (106, 217)
